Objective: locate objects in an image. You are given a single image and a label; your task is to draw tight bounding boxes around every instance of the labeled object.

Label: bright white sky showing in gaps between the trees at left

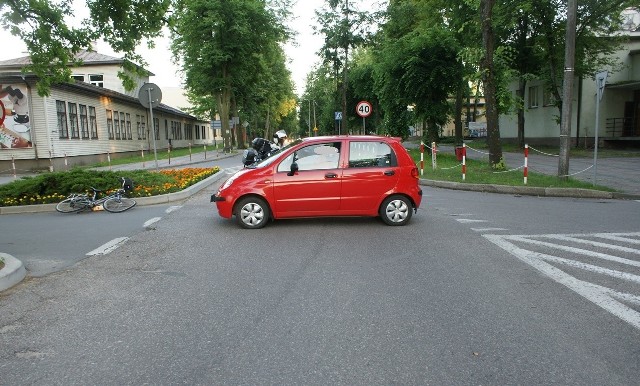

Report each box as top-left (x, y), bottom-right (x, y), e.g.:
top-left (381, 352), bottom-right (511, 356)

top-left (0, 0), bottom-right (324, 95)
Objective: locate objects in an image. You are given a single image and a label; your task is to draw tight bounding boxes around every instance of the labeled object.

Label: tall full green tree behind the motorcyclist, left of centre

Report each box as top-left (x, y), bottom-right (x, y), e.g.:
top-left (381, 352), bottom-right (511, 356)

top-left (172, 0), bottom-right (287, 149)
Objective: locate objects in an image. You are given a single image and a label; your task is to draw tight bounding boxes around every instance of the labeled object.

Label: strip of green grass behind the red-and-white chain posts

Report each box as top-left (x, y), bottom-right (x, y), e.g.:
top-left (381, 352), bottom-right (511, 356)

top-left (409, 146), bottom-right (616, 192)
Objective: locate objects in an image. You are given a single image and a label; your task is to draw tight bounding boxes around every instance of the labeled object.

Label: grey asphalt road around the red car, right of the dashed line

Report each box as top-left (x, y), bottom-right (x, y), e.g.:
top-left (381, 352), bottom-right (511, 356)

top-left (0, 182), bottom-right (640, 385)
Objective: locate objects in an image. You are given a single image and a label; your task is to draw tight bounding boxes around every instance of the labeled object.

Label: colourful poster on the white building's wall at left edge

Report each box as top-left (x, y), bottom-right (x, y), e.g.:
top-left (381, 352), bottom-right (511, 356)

top-left (0, 84), bottom-right (33, 149)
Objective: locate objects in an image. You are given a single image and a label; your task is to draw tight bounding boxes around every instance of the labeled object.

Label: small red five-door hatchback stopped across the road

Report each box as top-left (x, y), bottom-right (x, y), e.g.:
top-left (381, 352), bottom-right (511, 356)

top-left (211, 136), bottom-right (422, 229)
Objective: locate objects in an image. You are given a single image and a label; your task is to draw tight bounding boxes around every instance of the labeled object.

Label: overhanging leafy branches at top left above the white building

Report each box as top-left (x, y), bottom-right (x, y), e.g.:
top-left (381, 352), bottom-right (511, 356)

top-left (0, 0), bottom-right (171, 96)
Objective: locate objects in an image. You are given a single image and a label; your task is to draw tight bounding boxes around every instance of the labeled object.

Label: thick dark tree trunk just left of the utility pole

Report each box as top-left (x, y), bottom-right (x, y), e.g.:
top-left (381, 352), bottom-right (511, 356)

top-left (480, 0), bottom-right (502, 168)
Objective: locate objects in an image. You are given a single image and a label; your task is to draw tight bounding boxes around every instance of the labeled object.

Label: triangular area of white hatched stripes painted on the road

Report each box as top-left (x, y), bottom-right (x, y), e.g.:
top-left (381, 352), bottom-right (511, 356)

top-left (483, 232), bottom-right (640, 329)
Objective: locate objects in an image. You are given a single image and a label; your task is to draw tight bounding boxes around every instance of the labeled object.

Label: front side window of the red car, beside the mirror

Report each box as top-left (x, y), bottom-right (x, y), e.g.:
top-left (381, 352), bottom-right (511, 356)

top-left (278, 142), bottom-right (340, 172)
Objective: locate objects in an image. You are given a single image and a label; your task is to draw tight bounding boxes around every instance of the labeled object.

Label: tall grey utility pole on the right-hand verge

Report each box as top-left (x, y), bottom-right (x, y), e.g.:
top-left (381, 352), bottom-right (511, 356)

top-left (558, 0), bottom-right (578, 180)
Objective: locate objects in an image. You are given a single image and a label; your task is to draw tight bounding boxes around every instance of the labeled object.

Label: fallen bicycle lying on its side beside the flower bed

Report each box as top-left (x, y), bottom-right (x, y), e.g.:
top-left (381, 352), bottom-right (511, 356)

top-left (56, 177), bottom-right (136, 213)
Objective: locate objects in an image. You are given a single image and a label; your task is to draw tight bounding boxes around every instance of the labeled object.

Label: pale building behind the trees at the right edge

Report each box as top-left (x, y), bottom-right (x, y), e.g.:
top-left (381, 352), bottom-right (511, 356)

top-left (500, 9), bottom-right (640, 147)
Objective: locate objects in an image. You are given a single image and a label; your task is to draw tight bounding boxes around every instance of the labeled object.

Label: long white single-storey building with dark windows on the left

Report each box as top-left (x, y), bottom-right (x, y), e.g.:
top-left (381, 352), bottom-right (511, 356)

top-left (0, 51), bottom-right (215, 173)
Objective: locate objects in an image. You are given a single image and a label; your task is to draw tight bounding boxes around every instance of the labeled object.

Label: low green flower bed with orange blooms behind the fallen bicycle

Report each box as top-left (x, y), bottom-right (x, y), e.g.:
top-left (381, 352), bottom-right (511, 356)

top-left (0, 167), bottom-right (220, 206)
